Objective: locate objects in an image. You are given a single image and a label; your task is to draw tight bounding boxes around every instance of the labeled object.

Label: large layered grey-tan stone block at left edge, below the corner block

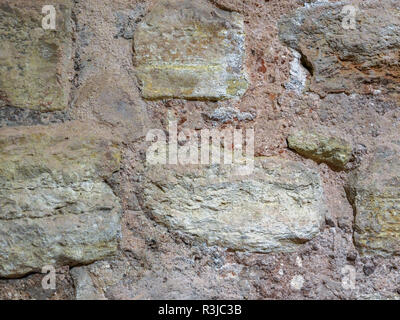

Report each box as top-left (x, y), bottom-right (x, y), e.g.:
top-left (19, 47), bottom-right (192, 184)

top-left (0, 122), bottom-right (121, 277)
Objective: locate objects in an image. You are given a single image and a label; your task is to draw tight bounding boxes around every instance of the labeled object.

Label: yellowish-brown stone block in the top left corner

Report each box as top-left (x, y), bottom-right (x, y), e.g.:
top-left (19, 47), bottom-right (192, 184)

top-left (0, 0), bottom-right (74, 111)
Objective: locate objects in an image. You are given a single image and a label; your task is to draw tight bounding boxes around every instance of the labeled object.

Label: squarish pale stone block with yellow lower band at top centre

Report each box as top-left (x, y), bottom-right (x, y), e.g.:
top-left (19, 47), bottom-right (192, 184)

top-left (134, 0), bottom-right (248, 100)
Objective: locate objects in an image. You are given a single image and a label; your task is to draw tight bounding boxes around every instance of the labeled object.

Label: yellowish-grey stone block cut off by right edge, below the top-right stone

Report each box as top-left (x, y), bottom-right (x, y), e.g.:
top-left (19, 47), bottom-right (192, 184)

top-left (348, 145), bottom-right (400, 256)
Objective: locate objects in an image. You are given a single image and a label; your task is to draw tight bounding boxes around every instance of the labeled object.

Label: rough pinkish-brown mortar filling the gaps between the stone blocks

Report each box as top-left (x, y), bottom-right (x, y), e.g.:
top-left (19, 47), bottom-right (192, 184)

top-left (0, 0), bottom-right (400, 300)
